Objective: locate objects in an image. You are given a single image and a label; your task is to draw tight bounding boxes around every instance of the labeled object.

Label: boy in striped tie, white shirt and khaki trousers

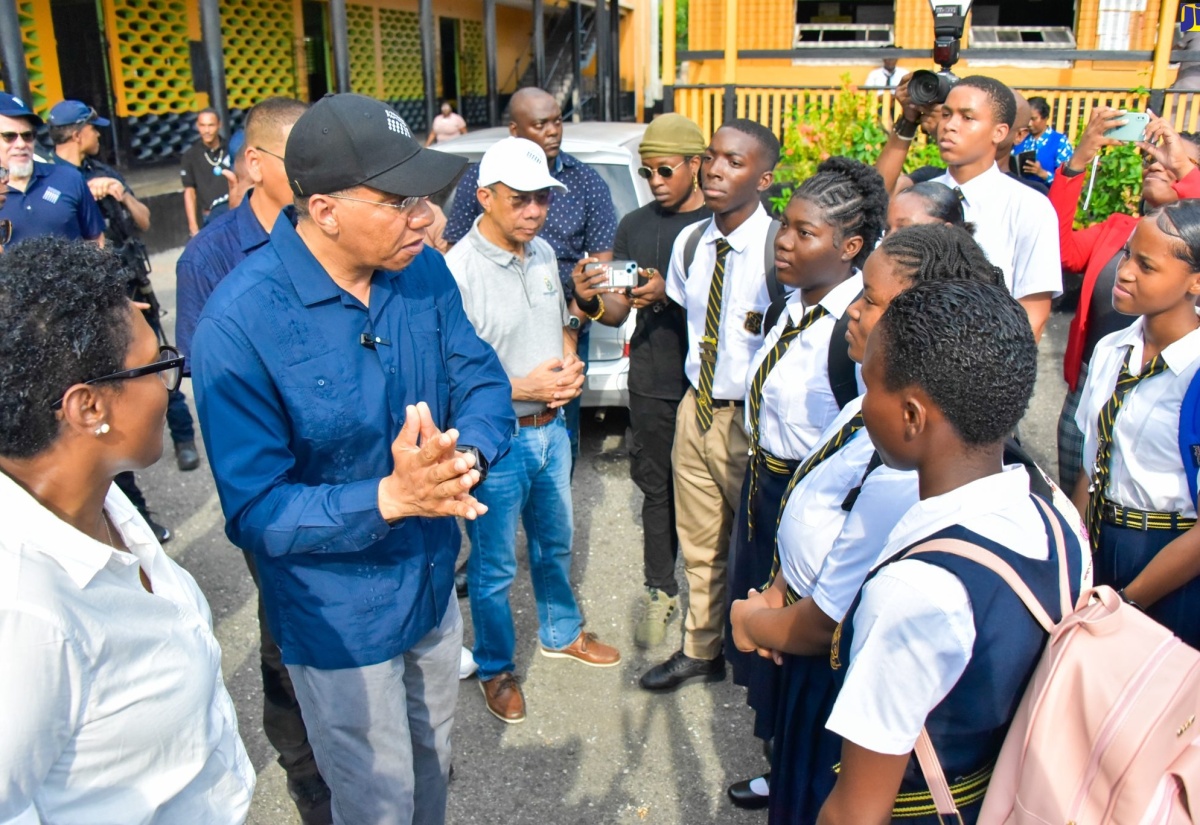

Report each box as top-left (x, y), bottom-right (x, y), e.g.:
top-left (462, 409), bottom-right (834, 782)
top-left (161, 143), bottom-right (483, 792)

top-left (641, 120), bottom-right (779, 691)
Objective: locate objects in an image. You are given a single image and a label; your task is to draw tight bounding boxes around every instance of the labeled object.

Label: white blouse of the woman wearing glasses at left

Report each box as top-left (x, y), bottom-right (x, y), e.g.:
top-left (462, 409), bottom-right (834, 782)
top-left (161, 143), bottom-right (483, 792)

top-left (0, 474), bottom-right (256, 825)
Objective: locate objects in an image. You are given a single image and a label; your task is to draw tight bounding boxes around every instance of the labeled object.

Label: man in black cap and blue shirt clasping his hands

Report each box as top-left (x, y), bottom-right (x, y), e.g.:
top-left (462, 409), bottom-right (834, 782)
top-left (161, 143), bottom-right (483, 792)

top-left (192, 95), bottom-right (516, 823)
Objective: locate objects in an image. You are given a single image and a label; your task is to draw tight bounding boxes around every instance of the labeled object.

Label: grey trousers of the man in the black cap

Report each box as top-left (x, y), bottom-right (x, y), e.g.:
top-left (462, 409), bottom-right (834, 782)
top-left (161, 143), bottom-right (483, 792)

top-left (287, 592), bottom-right (462, 825)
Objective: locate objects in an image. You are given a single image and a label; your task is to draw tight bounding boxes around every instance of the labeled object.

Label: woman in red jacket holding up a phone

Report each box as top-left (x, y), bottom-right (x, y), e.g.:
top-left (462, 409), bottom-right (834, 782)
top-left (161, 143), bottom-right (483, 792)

top-left (1050, 106), bottom-right (1200, 490)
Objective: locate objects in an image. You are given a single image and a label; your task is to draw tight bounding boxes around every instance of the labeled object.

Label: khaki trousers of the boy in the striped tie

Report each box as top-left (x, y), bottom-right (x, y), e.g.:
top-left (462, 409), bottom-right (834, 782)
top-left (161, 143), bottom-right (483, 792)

top-left (671, 389), bottom-right (750, 660)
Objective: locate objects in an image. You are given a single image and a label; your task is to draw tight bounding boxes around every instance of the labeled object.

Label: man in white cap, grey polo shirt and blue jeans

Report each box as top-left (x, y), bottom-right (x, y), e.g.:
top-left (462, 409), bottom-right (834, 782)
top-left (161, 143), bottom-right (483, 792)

top-left (446, 138), bottom-right (620, 723)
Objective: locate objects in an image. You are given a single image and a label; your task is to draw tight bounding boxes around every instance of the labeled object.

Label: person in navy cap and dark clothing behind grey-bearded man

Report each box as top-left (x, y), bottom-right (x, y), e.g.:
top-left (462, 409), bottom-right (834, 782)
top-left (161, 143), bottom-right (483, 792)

top-left (47, 101), bottom-right (200, 542)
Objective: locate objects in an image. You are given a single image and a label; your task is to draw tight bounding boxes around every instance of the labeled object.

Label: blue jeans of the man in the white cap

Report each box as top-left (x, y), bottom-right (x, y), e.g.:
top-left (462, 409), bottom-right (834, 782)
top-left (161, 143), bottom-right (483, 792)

top-left (467, 416), bottom-right (583, 679)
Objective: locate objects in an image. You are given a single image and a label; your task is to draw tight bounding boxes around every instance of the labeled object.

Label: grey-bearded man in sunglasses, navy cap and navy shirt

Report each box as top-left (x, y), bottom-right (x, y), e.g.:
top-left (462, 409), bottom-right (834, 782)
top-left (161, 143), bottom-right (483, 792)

top-left (0, 92), bottom-right (104, 243)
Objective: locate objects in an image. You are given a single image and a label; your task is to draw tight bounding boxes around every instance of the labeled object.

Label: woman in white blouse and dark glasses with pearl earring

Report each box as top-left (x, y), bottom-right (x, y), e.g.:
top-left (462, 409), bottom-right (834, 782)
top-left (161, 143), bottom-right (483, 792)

top-left (0, 237), bottom-right (254, 825)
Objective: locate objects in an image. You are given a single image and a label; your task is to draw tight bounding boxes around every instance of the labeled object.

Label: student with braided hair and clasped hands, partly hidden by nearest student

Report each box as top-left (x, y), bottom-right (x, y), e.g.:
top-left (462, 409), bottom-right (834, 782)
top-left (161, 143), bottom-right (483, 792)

top-left (730, 221), bottom-right (1004, 823)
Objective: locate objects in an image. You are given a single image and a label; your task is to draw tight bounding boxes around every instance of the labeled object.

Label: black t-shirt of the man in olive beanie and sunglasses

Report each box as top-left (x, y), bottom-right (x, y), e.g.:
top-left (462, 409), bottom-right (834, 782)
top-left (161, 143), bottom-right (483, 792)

top-left (612, 200), bottom-right (713, 401)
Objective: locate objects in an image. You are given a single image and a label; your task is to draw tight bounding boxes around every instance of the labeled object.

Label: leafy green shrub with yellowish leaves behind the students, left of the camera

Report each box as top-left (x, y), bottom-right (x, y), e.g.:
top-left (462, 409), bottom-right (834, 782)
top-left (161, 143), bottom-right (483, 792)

top-left (772, 74), bottom-right (942, 212)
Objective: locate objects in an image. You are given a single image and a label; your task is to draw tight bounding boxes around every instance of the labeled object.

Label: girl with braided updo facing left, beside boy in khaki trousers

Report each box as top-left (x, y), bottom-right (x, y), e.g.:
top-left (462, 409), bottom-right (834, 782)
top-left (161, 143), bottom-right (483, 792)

top-left (725, 157), bottom-right (888, 807)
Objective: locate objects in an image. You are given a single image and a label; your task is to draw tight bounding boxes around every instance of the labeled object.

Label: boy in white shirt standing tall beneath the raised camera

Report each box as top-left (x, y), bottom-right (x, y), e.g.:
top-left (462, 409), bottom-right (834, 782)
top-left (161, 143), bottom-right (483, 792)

top-left (934, 76), bottom-right (1062, 339)
